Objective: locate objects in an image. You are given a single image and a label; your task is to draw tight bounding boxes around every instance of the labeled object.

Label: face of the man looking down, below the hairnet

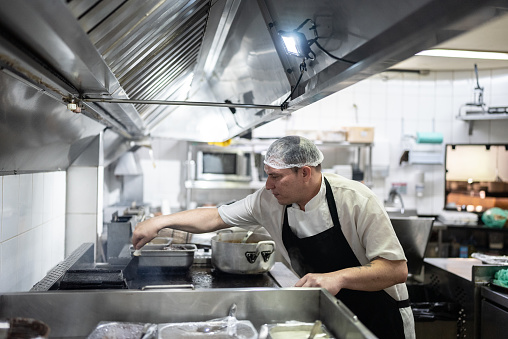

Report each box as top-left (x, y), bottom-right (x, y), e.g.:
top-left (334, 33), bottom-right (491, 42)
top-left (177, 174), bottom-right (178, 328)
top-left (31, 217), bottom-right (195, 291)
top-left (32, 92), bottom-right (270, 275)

top-left (264, 165), bottom-right (302, 205)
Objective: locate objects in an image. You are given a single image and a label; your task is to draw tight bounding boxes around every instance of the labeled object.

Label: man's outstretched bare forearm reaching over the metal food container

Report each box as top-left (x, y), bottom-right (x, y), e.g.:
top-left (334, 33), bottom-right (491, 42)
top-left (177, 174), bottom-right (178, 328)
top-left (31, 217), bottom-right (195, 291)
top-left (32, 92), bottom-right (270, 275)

top-left (132, 208), bottom-right (229, 249)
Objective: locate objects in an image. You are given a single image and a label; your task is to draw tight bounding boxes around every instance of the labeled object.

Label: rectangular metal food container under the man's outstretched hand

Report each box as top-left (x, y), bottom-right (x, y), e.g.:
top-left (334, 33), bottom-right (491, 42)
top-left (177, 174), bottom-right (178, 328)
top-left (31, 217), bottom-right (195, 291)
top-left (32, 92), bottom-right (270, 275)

top-left (130, 244), bottom-right (197, 269)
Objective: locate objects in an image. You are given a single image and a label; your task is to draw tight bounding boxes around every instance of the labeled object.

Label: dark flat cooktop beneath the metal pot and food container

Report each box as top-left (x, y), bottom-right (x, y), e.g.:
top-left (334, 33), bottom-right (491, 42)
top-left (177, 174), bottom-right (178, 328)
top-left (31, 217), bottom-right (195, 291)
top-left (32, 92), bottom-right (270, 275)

top-left (32, 244), bottom-right (286, 291)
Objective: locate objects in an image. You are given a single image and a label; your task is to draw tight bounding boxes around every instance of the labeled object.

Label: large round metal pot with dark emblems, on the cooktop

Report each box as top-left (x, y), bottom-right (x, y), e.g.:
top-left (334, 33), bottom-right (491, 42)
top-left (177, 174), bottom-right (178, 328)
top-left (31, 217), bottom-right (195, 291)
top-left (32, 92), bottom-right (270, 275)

top-left (211, 231), bottom-right (275, 274)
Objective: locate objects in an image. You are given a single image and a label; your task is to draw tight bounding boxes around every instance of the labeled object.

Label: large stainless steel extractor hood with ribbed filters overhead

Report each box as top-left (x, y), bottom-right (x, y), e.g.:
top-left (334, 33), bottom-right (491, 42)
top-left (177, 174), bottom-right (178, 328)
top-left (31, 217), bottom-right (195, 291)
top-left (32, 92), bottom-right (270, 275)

top-left (0, 0), bottom-right (508, 173)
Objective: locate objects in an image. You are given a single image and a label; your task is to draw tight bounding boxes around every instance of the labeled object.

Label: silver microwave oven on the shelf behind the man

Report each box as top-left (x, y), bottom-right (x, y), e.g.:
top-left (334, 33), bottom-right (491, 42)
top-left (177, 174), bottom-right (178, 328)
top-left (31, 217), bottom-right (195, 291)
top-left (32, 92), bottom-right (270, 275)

top-left (196, 147), bottom-right (252, 181)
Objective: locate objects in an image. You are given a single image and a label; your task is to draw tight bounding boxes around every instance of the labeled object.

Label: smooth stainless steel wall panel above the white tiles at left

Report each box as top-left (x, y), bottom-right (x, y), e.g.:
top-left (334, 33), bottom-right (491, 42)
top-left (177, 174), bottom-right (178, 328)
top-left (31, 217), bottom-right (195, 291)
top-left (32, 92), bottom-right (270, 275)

top-left (0, 72), bottom-right (104, 175)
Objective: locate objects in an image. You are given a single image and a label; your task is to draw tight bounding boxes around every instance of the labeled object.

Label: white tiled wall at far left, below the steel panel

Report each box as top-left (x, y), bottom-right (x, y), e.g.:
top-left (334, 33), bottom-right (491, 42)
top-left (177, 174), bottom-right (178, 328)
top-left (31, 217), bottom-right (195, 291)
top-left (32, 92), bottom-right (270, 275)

top-left (0, 172), bottom-right (66, 292)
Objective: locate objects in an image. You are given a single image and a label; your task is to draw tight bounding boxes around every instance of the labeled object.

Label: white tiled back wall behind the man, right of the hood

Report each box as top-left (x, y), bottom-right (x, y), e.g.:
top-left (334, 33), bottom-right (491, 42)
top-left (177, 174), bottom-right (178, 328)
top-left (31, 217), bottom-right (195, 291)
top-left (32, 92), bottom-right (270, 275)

top-left (253, 67), bottom-right (508, 215)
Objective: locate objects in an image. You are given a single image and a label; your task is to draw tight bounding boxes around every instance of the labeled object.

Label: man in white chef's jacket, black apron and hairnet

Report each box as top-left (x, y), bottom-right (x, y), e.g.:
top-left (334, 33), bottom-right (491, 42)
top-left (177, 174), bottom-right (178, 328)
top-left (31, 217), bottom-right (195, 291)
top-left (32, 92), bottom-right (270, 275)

top-left (132, 136), bottom-right (415, 339)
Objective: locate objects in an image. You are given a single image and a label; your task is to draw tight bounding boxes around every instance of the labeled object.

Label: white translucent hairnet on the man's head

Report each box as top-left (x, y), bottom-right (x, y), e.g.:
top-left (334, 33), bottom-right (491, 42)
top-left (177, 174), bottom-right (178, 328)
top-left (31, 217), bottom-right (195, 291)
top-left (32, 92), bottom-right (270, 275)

top-left (264, 135), bottom-right (324, 169)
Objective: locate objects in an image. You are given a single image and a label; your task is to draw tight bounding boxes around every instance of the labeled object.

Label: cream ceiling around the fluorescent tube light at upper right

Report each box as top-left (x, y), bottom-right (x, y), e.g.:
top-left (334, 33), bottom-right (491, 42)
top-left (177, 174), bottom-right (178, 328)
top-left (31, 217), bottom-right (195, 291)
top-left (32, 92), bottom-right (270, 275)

top-left (391, 14), bottom-right (508, 71)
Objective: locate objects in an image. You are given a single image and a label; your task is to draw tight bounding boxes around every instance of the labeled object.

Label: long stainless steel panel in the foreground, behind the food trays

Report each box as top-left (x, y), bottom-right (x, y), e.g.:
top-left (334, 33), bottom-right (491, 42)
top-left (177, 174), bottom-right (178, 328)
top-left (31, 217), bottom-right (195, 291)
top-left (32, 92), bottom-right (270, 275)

top-left (0, 288), bottom-right (375, 338)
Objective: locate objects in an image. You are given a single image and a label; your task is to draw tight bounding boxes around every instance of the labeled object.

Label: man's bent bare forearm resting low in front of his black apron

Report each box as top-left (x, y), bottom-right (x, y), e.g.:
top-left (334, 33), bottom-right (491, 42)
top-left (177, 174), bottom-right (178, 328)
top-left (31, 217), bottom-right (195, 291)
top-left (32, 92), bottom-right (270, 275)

top-left (295, 258), bottom-right (408, 295)
